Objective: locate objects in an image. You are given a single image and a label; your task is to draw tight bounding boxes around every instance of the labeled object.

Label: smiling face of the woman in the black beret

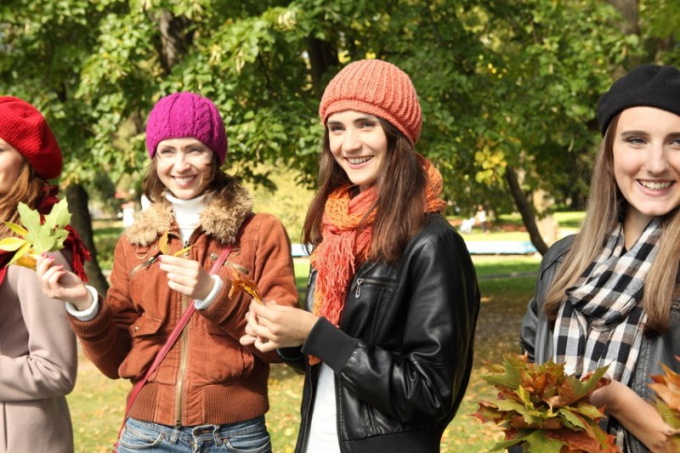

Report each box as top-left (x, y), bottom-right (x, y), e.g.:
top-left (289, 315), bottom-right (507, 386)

top-left (612, 107), bottom-right (680, 231)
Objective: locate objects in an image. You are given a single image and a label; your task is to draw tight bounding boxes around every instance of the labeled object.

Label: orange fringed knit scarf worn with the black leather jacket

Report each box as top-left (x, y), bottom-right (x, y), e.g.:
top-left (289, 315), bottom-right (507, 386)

top-left (311, 159), bottom-right (446, 354)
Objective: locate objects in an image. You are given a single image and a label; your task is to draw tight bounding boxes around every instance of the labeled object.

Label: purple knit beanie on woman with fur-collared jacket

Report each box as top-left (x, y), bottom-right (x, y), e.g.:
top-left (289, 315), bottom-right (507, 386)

top-left (146, 92), bottom-right (227, 165)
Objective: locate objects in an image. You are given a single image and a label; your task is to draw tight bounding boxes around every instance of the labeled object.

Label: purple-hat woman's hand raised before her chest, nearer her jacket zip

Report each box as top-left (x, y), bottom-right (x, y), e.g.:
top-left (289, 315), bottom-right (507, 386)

top-left (159, 255), bottom-right (215, 300)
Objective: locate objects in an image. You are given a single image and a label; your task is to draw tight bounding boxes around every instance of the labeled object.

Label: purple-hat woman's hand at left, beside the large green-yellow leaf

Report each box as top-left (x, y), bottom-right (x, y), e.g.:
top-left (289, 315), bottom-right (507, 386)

top-left (35, 254), bottom-right (93, 311)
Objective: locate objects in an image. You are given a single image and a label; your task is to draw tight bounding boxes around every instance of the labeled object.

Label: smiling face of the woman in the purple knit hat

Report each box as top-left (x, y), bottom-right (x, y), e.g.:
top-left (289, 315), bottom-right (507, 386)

top-left (155, 138), bottom-right (214, 200)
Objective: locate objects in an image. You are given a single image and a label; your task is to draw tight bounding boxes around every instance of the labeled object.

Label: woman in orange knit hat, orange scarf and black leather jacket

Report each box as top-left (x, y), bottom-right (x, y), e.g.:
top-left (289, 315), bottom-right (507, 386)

top-left (241, 60), bottom-right (479, 453)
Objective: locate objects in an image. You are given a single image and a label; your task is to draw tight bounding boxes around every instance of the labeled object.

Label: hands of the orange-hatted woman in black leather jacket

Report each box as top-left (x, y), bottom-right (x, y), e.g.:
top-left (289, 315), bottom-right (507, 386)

top-left (241, 302), bottom-right (319, 352)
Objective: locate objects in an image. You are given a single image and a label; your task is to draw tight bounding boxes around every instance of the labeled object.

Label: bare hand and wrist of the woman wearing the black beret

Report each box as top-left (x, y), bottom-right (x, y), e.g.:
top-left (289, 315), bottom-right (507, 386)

top-left (590, 381), bottom-right (675, 453)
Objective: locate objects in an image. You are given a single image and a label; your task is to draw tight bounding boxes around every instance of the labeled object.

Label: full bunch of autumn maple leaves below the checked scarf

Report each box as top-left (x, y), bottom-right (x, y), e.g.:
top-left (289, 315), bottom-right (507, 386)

top-left (474, 354), bottom-right (620, 453)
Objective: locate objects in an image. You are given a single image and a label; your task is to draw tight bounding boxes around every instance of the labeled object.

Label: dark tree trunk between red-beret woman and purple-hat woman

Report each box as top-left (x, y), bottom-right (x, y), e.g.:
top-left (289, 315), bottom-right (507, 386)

top-left (66, 184), bottom-right (109, 295)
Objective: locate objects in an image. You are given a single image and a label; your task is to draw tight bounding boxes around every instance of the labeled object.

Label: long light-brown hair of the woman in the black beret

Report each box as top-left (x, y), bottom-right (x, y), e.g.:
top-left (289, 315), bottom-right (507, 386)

top-left (545, 115), bottom-right (680, 335)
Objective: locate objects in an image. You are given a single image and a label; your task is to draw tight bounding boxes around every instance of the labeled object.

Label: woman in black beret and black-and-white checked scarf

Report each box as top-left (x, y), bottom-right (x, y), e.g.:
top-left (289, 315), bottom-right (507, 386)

top-left (521, 65), bottom-right (680, 452)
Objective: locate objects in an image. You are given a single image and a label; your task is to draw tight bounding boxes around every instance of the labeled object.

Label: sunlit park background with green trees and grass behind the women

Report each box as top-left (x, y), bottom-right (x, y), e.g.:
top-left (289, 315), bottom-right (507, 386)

top-left (0, 0), bottom-right (680, 451)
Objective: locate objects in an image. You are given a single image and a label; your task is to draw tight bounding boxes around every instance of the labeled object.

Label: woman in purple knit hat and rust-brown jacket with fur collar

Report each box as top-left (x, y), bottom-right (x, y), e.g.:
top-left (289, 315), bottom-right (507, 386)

top-left (38, 92), bottom-right (297, 452)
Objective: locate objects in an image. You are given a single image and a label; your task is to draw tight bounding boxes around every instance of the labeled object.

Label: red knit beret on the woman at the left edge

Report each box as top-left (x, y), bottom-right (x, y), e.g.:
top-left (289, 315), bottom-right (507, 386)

top-left (0, 96), bottom-right (63, 180)
